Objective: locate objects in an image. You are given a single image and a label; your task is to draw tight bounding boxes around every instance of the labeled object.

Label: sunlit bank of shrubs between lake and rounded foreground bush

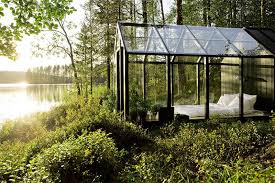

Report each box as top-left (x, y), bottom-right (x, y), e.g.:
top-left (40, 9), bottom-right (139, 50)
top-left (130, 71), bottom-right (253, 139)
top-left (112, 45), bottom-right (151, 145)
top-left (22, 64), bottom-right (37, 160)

top-left (21, 93), bottom-right (150, 164)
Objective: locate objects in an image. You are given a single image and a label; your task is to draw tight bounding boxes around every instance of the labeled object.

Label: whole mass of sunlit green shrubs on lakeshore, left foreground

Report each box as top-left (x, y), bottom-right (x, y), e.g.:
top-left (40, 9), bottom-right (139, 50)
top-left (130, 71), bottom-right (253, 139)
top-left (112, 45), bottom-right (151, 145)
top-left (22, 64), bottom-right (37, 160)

top-left (0, 93), bottom-right (152, 182)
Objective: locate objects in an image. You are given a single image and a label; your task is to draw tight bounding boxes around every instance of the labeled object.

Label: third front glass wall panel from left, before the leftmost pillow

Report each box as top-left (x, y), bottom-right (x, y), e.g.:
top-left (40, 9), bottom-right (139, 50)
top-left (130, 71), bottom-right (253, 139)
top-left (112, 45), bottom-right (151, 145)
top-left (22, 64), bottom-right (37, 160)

top-left (209, 57), bottom-right (241, 118)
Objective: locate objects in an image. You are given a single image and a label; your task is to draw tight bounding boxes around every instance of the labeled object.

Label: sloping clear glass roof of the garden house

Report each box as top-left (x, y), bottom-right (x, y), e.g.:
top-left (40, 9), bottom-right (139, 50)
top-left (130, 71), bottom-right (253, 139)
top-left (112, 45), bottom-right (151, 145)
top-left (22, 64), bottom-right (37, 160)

top-left (118, 23), bottom-right (273, 56)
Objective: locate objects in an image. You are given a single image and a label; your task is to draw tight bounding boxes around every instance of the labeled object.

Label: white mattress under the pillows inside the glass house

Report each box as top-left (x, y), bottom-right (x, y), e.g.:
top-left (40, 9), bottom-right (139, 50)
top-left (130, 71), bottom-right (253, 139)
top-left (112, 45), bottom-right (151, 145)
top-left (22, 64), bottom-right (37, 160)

top-left (174, 103), bottom-right (264, 118)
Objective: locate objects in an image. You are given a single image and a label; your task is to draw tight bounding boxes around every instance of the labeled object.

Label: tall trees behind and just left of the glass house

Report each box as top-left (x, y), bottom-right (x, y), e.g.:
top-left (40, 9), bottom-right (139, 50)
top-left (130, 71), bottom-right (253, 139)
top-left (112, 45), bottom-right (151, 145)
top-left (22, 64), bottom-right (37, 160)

top-left (16, 0), bottom-right (275, 95)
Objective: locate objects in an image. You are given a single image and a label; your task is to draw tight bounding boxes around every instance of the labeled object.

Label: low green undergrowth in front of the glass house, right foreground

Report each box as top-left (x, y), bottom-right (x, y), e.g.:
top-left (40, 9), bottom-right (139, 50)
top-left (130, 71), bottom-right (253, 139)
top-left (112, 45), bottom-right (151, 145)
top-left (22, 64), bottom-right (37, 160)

top-left (119, 120), bottom-right (275, 183)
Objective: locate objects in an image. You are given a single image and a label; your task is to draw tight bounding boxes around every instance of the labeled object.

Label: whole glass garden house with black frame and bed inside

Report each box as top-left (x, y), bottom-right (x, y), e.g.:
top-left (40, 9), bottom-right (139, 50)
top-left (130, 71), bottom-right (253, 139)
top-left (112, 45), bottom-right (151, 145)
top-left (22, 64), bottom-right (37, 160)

top-left (113, 22), bottom-right (275, 120)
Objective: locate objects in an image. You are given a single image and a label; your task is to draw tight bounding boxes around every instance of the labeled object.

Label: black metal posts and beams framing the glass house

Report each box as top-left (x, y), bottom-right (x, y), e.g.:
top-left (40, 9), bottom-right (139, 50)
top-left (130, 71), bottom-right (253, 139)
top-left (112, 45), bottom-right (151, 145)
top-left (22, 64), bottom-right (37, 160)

top-left (116, 23), bottom-right (275, 119)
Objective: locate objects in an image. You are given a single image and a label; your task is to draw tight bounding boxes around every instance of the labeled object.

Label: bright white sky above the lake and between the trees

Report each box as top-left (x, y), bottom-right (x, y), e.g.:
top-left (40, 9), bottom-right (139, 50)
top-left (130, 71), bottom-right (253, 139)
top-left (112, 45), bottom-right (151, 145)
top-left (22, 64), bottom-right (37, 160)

top-left (0, 0), bottom-right (174, 71)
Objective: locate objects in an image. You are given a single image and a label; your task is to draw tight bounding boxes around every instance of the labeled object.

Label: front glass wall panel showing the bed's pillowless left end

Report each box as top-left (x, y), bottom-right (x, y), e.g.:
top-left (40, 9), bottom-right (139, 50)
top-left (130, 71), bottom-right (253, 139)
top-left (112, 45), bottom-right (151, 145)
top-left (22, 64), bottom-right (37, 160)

top-left (174, 56), bottom-right (205, 119)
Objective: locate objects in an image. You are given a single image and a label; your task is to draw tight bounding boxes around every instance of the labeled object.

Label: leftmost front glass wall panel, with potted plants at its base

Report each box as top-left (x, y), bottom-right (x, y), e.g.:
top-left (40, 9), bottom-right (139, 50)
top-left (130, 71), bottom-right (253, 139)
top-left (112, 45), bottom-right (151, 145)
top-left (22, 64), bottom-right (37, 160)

top-left (129, 55), bottom-right (167, 121)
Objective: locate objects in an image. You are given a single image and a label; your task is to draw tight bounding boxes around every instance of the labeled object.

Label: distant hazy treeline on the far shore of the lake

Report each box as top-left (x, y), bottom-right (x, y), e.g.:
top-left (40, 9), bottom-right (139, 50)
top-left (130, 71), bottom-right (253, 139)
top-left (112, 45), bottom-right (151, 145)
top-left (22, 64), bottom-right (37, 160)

top-left (25, 65), bottom-right (72, 84)
